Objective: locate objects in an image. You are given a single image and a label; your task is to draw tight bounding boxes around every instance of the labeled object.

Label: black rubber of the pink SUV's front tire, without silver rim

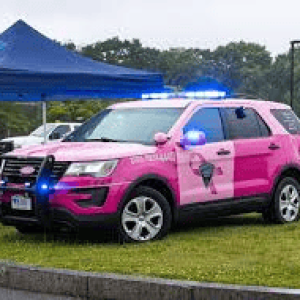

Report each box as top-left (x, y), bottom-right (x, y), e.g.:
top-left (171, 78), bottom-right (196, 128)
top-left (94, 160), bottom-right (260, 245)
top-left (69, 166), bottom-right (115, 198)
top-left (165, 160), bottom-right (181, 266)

top-left (119, 186), bottom-right (172, 243)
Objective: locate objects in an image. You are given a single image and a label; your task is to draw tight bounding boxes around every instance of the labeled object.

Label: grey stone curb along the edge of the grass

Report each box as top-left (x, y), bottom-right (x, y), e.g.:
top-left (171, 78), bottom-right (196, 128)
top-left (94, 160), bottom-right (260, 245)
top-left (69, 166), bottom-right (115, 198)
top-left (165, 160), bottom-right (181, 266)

top-left (0, 263), bottom-right (300, 300)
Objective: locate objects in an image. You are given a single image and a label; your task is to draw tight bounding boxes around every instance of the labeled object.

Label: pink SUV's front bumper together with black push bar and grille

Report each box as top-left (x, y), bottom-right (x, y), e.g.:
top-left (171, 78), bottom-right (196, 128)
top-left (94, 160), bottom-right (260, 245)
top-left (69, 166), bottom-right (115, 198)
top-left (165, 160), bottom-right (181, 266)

top-left (0, 156), bottom-right (130, 228)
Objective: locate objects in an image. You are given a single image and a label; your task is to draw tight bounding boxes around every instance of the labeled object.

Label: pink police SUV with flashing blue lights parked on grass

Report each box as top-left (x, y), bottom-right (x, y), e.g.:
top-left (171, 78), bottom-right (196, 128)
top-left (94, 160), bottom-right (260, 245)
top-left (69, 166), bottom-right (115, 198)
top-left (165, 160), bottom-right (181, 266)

top-left (0, 99), bottom-right (300, 241)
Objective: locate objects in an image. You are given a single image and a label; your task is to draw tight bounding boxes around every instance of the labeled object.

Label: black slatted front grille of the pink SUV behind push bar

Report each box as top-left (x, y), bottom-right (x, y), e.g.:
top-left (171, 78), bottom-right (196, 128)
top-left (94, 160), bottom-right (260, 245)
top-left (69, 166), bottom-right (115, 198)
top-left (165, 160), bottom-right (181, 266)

top-left (2, 157), bottom-right (70, 183)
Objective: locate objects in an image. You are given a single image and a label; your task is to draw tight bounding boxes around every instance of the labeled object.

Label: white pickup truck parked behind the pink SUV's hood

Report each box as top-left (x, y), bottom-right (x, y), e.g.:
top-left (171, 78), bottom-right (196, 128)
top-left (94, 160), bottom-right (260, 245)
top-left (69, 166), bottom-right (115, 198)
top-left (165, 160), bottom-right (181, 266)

top-left (1, 123), bottom-right (81, 149)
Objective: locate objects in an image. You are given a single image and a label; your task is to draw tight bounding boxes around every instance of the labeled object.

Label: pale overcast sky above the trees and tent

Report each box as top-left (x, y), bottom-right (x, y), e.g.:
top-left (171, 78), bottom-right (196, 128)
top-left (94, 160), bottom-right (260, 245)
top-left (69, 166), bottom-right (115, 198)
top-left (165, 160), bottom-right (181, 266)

top-left (0, 0), bottom-right (300, 55)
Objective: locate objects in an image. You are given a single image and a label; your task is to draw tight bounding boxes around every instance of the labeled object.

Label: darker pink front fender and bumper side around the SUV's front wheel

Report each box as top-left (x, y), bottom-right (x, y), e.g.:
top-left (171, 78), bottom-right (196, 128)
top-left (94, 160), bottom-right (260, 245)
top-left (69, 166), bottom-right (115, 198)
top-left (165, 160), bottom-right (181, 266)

top-left (50, 149), bottom-right (179, 215)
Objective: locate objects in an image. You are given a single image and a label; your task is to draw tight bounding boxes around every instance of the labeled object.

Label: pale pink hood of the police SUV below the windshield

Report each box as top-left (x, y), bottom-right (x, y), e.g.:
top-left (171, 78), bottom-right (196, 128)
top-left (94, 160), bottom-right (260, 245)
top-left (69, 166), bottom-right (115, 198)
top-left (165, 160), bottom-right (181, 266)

top-left (9, 142), bottom-right (157, 161)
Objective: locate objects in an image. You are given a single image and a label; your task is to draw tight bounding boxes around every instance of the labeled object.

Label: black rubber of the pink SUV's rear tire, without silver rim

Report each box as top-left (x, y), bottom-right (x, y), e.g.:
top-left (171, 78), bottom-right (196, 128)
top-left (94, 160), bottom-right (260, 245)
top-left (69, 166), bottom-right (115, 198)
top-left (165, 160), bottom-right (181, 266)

top-left (273, 177), bottom-right (300, 224)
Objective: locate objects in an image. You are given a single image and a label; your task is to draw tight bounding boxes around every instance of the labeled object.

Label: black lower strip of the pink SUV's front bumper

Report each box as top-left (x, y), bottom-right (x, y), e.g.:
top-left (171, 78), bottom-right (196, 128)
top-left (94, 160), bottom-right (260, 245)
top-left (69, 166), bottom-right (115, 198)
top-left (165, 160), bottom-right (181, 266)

top-left (0, 207), bottom-right (119, 230)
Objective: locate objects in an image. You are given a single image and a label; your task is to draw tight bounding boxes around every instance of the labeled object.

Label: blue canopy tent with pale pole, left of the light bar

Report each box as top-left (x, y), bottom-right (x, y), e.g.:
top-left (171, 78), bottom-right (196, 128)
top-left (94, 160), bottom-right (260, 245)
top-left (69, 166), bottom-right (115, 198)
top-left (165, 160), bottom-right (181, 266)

top-left (0, 20), bottom-right (163, 142)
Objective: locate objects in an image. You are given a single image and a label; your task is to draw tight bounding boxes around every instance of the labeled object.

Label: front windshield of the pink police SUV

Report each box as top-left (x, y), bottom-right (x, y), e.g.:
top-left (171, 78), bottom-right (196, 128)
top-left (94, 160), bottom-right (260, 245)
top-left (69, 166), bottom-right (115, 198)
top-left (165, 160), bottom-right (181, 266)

top-left (64, 108), bottom-right (183, 144)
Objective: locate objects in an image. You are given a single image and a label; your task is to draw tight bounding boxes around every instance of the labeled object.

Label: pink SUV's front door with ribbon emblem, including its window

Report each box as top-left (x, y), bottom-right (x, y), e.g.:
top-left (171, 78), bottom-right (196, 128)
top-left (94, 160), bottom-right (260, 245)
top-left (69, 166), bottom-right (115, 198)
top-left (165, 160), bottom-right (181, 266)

top-left (176, 108), bottom-right (234, 205)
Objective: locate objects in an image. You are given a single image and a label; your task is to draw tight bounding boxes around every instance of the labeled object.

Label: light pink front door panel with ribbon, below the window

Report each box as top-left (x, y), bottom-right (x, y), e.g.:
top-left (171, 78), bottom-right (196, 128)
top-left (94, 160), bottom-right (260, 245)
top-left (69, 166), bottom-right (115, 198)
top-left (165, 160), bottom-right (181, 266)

top-left (177, 141), bottom-right (234, 205)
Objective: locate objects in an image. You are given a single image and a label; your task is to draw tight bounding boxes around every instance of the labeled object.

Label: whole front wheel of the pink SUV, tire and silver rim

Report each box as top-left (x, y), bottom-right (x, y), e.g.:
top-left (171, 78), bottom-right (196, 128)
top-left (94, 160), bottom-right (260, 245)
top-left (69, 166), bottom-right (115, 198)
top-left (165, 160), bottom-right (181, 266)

top-left (119, 186), bottom-right (172, 242)
